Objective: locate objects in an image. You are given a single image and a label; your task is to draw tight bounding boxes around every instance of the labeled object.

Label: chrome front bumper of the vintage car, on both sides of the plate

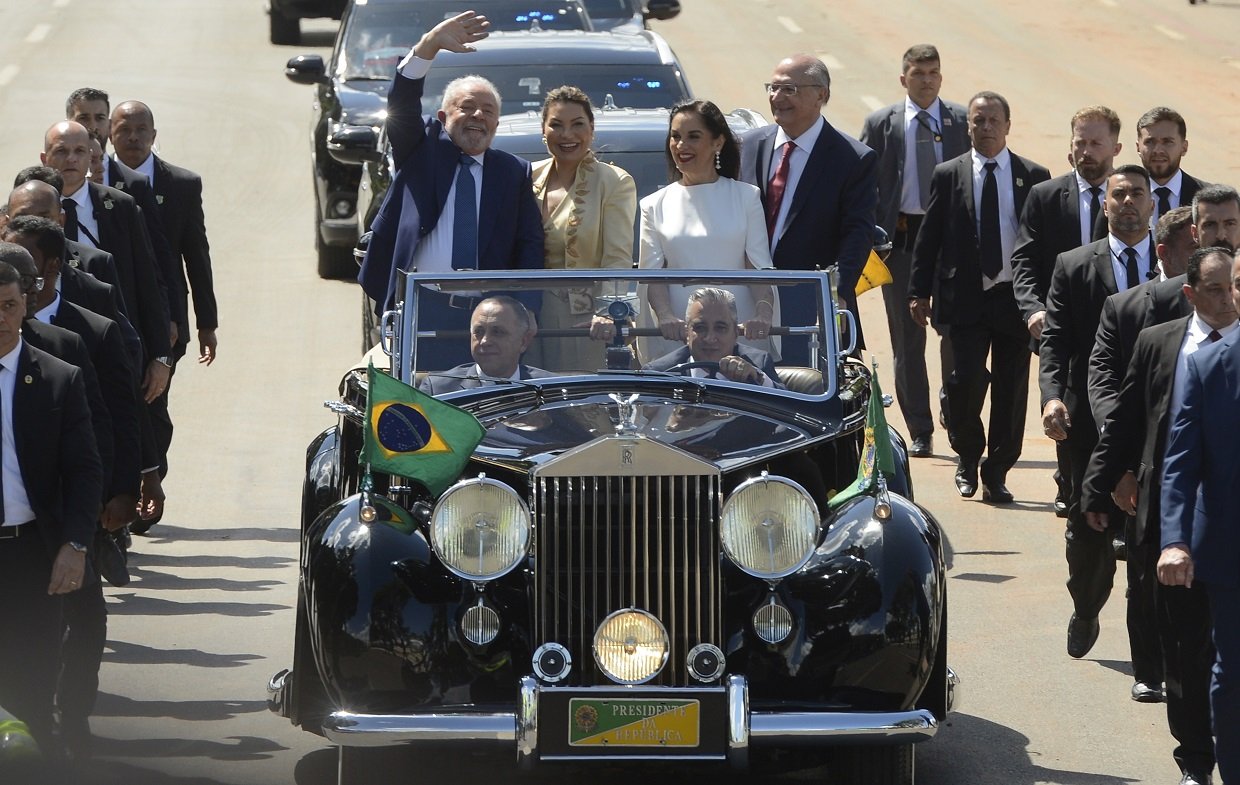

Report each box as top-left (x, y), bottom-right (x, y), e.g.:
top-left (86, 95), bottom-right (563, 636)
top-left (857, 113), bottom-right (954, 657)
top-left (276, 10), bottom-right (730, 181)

top-left (322, 676), bottom-right (939, 765)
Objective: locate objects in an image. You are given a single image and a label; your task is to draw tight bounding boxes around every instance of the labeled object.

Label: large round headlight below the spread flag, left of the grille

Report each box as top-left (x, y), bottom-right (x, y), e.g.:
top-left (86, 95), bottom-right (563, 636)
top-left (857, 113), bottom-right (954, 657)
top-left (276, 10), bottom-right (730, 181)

top-left (430, 477), bottom-right (529, 580)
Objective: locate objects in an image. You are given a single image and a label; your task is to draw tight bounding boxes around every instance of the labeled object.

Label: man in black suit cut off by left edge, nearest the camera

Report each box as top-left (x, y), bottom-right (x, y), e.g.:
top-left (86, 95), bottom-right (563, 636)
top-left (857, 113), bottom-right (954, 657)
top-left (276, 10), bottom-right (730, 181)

top-left (0, 264), bottom-right (103, 754)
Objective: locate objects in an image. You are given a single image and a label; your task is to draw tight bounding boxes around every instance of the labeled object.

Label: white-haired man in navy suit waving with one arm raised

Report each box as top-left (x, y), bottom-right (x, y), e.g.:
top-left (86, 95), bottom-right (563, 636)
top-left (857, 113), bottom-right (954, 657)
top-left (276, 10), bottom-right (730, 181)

top-left (357, 11), bottom-right (543, 365)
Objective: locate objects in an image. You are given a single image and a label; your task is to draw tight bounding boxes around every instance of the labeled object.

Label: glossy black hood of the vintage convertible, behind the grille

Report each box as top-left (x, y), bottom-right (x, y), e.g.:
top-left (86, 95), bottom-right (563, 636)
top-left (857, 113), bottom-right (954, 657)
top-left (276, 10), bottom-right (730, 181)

top-left (466, 393), bottom-right (839, 472)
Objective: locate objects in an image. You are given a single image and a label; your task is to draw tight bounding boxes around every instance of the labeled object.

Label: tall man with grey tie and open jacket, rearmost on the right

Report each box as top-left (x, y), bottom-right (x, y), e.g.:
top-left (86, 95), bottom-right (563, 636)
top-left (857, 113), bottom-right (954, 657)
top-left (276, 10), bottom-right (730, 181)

top-left (861, 43), bottom-right (968, 458)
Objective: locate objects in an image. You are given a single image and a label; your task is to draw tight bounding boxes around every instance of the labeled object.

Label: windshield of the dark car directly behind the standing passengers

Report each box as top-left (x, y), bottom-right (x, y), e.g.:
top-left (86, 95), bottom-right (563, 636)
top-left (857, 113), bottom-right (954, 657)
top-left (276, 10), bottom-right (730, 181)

top-left (422, 63), bottom-right (688, 114)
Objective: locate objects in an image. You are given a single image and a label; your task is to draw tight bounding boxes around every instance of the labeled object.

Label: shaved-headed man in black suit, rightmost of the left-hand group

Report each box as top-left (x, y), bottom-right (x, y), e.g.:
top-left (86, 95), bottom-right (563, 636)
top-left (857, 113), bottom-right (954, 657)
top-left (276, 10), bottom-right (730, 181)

top-left (112, 100), bottom-right (219, 365)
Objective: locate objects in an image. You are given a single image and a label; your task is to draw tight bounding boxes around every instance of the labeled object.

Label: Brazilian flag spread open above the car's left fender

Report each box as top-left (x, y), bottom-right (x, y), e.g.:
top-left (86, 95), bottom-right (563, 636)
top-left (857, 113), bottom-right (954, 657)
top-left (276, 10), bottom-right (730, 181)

top-left (361, 363), bottom-right (486, 496)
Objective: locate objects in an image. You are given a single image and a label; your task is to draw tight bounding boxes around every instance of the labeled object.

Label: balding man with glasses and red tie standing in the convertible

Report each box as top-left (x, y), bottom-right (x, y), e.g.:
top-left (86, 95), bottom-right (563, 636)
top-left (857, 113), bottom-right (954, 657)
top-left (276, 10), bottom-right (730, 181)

top-left (740, 55), bottom-right (878, 366)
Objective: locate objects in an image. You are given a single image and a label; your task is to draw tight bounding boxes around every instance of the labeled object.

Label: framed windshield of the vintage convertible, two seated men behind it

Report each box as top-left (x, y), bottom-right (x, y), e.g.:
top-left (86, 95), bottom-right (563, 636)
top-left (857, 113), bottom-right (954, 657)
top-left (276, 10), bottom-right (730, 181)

top-left (386, 269), bottom-right (848, 397)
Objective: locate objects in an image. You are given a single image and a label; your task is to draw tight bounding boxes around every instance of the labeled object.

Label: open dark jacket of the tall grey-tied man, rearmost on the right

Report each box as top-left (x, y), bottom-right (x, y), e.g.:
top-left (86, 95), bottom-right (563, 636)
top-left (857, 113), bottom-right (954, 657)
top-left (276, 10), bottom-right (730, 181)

top-left (861, 98), bottom-right (968, 237)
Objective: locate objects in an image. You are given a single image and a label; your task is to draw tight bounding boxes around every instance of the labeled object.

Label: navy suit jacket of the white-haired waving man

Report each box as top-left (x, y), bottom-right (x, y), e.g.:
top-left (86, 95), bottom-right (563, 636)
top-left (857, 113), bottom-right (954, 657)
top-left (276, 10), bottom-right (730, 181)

top-left (357, 74), bottom-right (543, 310)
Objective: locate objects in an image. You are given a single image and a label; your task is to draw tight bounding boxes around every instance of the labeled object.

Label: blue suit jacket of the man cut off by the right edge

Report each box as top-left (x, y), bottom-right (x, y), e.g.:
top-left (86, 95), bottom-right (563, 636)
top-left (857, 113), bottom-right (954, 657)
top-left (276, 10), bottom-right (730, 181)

top-left (1162, 332), bottom-right (1240, 588)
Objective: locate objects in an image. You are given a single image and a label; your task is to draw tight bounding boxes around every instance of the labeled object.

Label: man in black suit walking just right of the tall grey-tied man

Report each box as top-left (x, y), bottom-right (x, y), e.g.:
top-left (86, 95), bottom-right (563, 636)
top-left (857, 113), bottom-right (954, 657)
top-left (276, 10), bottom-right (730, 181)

top-left (908, 92), bottom-right (1050, 503)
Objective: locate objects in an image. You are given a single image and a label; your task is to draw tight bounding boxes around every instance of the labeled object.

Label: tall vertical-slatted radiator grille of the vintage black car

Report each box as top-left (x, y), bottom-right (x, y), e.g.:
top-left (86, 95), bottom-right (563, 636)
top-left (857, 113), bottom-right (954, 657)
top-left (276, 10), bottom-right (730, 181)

top-left (532, 474), bottom-right (722, 686)
